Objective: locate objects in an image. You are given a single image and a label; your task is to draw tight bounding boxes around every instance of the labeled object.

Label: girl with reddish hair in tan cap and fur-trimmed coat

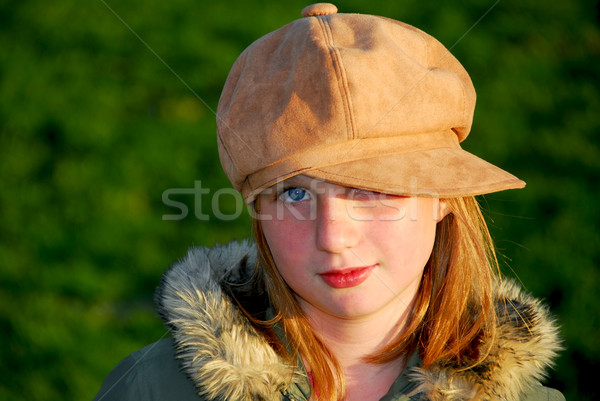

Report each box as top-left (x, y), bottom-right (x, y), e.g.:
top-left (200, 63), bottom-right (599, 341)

top-left (96, 4), bottom-right (563, 401)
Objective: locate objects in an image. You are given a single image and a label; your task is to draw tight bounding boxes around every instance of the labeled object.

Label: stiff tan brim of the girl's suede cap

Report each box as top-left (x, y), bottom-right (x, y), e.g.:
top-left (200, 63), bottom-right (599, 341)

top-left (303, 148), bottom-right (525, 198)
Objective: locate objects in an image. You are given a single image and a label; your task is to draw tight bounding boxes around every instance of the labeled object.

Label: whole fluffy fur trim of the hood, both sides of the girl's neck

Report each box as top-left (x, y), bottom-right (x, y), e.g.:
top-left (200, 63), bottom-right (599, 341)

top-left (156, 242), bottom-right (560, 401)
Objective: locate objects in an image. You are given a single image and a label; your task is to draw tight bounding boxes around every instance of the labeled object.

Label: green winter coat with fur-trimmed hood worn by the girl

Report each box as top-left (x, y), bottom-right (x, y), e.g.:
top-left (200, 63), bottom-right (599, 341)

top-left (94, 239), bottom-right (564, 401)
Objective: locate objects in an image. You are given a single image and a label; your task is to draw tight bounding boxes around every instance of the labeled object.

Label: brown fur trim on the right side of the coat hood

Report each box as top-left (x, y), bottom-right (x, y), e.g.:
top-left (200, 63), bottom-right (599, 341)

top-left (410, 280), bottom-right (562, 401)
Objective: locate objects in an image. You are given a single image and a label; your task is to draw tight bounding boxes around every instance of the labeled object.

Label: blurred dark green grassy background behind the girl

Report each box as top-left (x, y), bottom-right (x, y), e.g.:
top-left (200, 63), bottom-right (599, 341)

top-left (0, 0), bottom-right (600, 401)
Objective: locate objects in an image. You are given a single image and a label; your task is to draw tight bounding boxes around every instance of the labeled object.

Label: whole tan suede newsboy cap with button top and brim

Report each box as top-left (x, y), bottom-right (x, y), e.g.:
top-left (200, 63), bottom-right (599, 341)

top-left (217, 3), bottom-right (525, 203)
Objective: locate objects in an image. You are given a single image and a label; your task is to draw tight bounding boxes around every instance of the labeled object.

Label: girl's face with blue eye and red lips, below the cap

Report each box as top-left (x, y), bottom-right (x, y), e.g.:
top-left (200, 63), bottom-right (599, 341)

top-left (259, 176), bottom-right (445, 319)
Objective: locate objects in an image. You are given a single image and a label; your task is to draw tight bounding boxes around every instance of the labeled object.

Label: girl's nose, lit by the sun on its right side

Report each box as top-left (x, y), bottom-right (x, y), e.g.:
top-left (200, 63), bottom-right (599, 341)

top-left (316, 195), bottom-right (360, 253)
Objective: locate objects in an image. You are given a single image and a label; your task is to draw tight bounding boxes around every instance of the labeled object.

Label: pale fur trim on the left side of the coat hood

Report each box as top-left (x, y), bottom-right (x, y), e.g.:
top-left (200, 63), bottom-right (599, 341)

top-left (156, 242), bottom-right (293, 401)
